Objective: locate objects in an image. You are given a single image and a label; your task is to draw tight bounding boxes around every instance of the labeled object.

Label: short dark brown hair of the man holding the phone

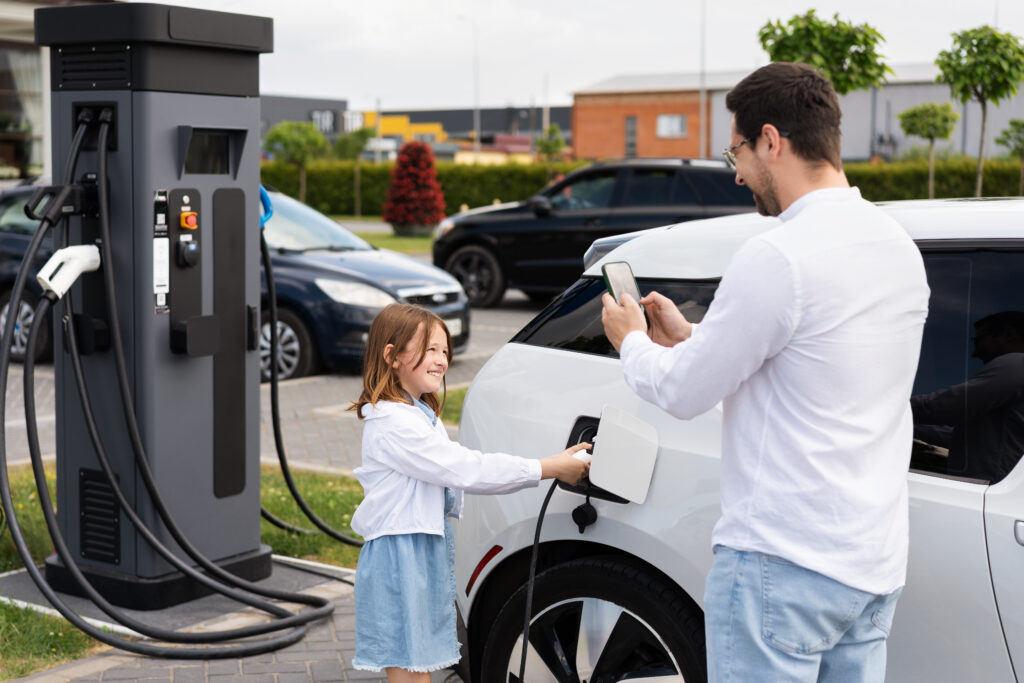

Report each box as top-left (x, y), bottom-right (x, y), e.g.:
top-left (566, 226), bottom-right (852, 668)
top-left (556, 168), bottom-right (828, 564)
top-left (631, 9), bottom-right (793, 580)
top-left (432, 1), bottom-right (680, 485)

top-left (725, 61), bottom-right (843, 171)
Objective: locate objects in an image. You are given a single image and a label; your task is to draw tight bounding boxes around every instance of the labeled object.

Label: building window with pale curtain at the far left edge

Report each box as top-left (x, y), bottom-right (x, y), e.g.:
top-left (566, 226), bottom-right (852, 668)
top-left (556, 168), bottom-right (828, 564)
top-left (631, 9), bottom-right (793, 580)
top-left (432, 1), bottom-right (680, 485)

top-left (0, 44), bottom-right (45, 178)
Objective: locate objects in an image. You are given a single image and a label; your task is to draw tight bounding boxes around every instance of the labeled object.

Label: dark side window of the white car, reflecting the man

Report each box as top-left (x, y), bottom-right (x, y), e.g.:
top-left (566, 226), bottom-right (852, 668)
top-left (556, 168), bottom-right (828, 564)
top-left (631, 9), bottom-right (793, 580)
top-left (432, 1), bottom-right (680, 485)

top-left (910, 250), bottom-right (1024, 483)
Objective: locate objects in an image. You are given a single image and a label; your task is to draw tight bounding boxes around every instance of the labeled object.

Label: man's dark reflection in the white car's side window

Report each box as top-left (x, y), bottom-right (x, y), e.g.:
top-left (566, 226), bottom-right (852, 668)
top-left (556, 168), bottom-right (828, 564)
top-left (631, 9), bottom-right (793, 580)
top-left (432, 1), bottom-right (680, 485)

top-left (910, 310), bottom-right (1024, 483)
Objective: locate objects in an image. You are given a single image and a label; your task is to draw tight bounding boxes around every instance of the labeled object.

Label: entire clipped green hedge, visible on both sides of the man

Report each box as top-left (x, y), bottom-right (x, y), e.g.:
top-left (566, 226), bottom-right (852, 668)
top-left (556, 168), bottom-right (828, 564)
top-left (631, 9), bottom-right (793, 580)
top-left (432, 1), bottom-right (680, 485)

top-left (262, 159), bottom-right (1020, 216)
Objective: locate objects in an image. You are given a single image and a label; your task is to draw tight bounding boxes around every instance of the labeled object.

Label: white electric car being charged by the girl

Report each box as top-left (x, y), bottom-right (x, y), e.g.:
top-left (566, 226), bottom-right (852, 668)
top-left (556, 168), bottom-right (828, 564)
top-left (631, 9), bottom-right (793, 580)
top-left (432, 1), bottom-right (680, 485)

top-left (456, 200), bottom-right (1024, 683)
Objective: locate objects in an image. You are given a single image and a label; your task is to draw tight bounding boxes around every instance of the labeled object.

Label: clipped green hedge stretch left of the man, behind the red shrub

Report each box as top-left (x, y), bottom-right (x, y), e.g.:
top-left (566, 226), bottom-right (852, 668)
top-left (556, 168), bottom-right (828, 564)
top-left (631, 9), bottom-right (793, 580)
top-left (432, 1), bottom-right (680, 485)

top-left (262, 161), bottom-right (583, 216)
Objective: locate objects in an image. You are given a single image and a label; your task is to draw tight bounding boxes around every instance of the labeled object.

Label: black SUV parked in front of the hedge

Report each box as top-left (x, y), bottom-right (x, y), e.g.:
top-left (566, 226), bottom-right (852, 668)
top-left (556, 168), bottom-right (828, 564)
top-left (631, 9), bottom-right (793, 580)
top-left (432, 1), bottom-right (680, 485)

top-left (433, 159), bottom-right (754, 306)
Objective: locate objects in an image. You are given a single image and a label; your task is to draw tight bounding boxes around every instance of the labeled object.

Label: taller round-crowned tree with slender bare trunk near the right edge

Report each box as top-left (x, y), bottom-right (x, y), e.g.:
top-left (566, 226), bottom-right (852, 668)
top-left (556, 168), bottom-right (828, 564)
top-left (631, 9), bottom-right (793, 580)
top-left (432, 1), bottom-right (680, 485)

top-left (935, 26), bottom-right (1024, 197)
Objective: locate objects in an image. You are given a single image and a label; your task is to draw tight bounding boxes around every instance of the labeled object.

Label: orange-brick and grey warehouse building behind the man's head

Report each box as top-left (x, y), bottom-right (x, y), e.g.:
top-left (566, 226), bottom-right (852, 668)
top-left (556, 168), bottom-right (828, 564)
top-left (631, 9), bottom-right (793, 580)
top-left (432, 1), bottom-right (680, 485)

top-left (572, 63), bottom-right (1024, 161)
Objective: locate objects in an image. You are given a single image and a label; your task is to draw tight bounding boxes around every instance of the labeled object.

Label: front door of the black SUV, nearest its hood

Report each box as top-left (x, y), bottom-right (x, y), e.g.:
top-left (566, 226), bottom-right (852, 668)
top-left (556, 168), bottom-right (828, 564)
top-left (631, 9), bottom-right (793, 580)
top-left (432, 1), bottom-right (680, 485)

top-left (502, 168), bottom-right (618, 291)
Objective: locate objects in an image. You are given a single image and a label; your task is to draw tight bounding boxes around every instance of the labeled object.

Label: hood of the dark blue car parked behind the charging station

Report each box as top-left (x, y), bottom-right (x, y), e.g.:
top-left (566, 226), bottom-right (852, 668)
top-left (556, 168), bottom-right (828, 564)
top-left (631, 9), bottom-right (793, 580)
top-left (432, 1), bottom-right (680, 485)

top-left (273, 249), bottom-right (459, 294)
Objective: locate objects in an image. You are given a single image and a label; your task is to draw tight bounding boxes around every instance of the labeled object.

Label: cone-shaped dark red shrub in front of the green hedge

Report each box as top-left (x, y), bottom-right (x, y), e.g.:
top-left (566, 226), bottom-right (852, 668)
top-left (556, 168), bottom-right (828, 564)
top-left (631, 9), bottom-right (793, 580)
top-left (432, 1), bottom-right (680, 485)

top-left (384, 140), bottom-right (444, 232)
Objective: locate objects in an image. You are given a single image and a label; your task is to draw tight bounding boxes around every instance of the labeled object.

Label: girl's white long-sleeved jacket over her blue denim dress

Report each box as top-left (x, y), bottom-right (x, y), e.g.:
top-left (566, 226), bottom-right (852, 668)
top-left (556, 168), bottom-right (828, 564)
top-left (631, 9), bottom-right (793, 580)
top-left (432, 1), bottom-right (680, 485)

top-left (352, 400), bottom-right (541, 541)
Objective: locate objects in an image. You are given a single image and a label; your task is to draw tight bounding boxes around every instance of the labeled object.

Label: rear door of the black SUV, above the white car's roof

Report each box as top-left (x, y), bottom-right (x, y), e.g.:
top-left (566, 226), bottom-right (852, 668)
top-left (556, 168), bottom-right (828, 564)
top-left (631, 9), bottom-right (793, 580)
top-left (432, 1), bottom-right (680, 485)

top-left (598, 168), bottom-right (705, 239)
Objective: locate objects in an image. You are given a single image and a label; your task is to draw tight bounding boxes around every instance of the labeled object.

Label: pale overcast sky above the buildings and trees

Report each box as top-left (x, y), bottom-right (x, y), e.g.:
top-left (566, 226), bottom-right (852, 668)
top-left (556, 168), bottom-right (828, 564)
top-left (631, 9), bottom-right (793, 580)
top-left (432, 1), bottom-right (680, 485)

top-left (134, 0), bottom-right (1024, 111)
